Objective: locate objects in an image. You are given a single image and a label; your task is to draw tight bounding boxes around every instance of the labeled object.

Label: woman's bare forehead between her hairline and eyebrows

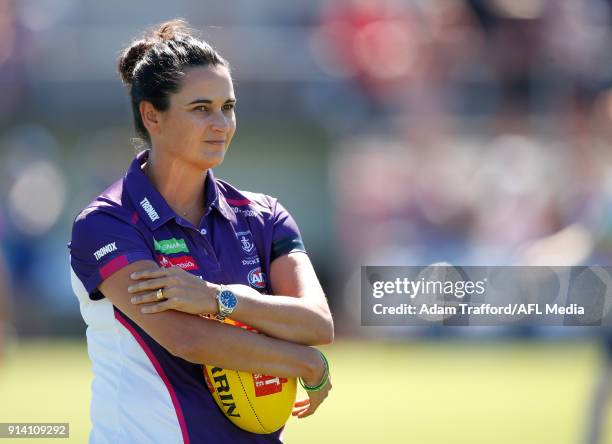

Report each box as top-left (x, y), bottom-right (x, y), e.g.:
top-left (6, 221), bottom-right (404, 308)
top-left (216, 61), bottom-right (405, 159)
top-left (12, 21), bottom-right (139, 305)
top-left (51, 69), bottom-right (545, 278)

top-left (175, 66), bottom-right (234, 102)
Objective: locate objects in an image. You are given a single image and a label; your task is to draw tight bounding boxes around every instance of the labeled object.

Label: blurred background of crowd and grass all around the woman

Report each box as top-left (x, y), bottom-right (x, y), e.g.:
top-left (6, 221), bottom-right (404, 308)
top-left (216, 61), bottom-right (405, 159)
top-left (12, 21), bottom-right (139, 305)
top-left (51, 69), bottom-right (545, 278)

top-left (0, 0), bottom-right (612, 444)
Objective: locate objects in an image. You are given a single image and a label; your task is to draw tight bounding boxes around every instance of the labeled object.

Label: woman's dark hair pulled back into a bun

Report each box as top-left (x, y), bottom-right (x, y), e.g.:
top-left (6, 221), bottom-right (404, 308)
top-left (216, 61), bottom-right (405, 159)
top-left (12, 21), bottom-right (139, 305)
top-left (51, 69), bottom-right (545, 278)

top-left (118, 19), bottom-right (229, 144)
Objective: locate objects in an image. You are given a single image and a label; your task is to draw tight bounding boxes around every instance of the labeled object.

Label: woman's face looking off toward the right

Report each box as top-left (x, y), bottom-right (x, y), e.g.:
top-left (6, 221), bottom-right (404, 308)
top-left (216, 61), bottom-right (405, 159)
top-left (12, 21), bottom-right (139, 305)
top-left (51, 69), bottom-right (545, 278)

top-left (151, 66), bottom-right (236, 169)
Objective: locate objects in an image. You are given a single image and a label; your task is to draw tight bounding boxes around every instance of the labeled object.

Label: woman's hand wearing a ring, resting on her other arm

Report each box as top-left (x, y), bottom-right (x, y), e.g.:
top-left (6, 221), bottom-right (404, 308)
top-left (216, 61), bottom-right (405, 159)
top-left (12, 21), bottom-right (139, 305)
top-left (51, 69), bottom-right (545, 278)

top-left (128, 266), bottom-right (218, 315)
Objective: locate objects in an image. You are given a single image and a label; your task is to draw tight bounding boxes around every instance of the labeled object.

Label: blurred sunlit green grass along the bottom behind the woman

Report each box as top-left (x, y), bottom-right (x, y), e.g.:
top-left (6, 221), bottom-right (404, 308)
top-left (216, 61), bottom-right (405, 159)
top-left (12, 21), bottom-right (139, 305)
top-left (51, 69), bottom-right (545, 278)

top-left (0, 342), bottom-right (612, 444)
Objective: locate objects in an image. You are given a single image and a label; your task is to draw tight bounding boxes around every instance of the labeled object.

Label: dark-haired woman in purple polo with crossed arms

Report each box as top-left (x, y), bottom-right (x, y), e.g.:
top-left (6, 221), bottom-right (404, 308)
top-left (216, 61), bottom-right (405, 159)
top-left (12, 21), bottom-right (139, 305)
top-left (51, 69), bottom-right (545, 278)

top-left (70, 21), bottom-right (333, 444)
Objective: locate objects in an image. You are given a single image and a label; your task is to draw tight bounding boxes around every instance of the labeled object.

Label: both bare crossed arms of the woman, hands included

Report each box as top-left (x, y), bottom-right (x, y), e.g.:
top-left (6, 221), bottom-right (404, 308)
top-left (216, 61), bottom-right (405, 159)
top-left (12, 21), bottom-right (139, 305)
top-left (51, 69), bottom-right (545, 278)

top-left (99, 253), bottom-right (333, 417)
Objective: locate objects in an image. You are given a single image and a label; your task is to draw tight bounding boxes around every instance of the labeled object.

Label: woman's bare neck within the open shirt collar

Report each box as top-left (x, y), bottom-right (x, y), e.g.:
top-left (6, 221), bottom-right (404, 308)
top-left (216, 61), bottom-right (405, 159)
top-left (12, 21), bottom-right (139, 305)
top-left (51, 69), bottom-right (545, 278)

top-left (143, 150), bottom-right (208, 225)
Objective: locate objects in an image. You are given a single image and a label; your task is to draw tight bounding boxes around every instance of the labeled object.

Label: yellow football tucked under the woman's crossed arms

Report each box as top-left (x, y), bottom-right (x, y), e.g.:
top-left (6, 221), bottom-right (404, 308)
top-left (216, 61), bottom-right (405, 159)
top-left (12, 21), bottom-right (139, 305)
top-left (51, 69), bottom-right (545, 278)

top-left (204, 319), bottom-right (297, 434)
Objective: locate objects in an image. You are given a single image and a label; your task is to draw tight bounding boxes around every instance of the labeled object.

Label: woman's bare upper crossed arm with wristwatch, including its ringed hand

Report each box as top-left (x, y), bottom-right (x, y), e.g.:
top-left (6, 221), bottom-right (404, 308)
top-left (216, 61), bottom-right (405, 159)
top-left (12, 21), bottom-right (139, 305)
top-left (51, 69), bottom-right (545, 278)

top-left (128, 253), bottom-right (334, 345)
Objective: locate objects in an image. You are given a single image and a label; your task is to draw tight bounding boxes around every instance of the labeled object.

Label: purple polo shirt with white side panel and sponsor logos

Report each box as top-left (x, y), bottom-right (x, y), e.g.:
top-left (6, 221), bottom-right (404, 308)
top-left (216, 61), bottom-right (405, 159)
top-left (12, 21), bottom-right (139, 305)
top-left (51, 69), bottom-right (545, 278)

top-left (69, 151), bottom-right (304, 443)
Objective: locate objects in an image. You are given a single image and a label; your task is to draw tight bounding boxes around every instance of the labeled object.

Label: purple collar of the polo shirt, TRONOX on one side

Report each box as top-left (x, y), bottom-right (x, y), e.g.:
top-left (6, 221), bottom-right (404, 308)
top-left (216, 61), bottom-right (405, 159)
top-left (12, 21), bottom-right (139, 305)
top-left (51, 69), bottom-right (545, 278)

top-left (123, 150), bottom-right (233, 230)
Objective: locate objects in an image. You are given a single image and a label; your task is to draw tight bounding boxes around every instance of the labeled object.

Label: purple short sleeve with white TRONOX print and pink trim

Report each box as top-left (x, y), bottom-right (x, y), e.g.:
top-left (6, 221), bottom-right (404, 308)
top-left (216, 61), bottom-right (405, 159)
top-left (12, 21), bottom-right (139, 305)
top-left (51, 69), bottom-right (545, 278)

top-left (68, 211), bottom-right (155, 297)
